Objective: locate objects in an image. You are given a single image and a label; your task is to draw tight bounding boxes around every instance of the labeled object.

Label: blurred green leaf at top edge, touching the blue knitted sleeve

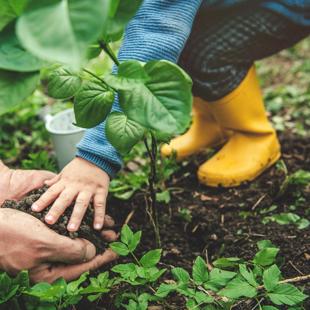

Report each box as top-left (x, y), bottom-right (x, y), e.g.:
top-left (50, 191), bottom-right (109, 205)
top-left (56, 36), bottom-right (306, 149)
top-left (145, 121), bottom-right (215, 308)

top-left (103, 0), bottom-right (143, 42)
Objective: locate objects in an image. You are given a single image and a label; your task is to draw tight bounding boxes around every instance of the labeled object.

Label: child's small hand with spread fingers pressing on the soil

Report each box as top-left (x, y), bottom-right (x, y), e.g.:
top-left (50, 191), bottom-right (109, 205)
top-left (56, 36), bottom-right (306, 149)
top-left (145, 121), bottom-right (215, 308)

top-left (32, 158), bottom-right (110, 231)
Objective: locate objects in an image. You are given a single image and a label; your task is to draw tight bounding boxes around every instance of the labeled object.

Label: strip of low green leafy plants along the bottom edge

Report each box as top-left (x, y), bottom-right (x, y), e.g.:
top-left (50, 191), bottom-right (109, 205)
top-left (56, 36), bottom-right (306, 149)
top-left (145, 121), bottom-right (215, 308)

top-left (0, 225), bottom-right (310, 310)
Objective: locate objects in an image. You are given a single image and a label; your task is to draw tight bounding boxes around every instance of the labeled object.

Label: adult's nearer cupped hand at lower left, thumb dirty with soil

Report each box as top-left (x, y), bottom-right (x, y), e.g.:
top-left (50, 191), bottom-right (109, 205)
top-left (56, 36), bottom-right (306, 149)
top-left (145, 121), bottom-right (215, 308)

top-left (0, 208), bottom-right (117, 283)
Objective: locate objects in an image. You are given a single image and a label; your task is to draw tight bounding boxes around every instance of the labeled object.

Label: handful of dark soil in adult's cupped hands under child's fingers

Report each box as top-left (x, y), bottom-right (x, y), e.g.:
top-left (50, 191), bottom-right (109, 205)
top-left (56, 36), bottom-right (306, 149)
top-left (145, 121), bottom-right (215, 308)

top-left (2, 187), bottom-right (107, 253)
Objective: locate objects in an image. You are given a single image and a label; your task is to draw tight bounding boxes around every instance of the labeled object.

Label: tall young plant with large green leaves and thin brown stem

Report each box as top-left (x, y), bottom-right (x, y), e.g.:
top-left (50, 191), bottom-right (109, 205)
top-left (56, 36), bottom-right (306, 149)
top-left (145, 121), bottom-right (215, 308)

top-left (0, 0), bottom-right (192, 245)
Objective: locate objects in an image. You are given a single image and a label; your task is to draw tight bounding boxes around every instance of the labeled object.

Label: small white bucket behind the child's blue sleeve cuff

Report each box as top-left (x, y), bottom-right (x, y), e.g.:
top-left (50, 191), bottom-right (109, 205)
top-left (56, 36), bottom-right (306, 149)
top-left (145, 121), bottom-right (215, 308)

top-left (45, 109), bottom-right (85, 169)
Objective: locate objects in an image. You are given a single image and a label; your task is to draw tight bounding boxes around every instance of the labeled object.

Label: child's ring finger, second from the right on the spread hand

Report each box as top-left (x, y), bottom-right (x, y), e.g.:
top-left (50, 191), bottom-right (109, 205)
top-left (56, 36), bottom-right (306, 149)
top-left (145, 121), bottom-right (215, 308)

top-left (67, 192), bottom-right (92, 231)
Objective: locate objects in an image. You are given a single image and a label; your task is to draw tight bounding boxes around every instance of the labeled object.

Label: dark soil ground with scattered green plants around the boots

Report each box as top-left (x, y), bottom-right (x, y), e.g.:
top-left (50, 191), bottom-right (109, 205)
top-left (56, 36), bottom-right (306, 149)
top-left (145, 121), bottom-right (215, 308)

top-left (0, 40), bottom-right (310, 310)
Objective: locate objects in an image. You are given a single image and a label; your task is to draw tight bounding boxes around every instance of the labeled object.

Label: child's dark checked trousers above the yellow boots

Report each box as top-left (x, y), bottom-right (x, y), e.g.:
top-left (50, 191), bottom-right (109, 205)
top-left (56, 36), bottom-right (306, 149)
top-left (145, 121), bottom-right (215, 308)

top-left (179, 6), bottom-right (310, 101)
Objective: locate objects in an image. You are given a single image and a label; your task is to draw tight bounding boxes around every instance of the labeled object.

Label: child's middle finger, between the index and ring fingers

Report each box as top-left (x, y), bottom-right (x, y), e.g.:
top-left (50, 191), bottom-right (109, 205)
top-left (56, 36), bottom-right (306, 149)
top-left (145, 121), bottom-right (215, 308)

top-left (45, 189), bottom-right (77, 225)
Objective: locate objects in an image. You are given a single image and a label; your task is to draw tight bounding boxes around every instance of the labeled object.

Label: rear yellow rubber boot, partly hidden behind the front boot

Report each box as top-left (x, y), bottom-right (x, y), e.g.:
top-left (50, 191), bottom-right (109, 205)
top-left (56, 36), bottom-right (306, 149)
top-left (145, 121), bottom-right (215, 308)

top-left (161, 97), bottom-right (225, 160)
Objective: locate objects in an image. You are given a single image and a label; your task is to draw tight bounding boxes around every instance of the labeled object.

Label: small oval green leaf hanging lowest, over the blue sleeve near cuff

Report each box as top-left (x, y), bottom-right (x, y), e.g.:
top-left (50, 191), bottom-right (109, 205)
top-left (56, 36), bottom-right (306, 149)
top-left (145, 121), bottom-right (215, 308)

top-left (105, 112), bottom-right (145, 154)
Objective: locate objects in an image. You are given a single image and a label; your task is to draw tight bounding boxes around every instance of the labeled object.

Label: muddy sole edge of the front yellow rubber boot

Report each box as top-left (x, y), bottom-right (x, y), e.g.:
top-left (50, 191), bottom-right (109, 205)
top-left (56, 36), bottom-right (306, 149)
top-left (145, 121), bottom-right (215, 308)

top-left (197, 152), bottom-right (281, 188)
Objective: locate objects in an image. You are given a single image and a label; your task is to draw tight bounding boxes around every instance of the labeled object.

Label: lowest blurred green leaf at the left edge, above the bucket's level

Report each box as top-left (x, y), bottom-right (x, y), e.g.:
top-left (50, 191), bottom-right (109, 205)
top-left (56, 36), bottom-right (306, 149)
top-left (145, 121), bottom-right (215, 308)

top-left (0, 70), bottom-right (40, 115)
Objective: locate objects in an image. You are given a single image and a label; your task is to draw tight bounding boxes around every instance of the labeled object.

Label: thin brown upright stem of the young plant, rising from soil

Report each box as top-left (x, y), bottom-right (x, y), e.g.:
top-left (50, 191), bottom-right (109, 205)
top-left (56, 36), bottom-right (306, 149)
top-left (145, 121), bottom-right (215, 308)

top-left (144, 133), bottom-right (161, 248)
